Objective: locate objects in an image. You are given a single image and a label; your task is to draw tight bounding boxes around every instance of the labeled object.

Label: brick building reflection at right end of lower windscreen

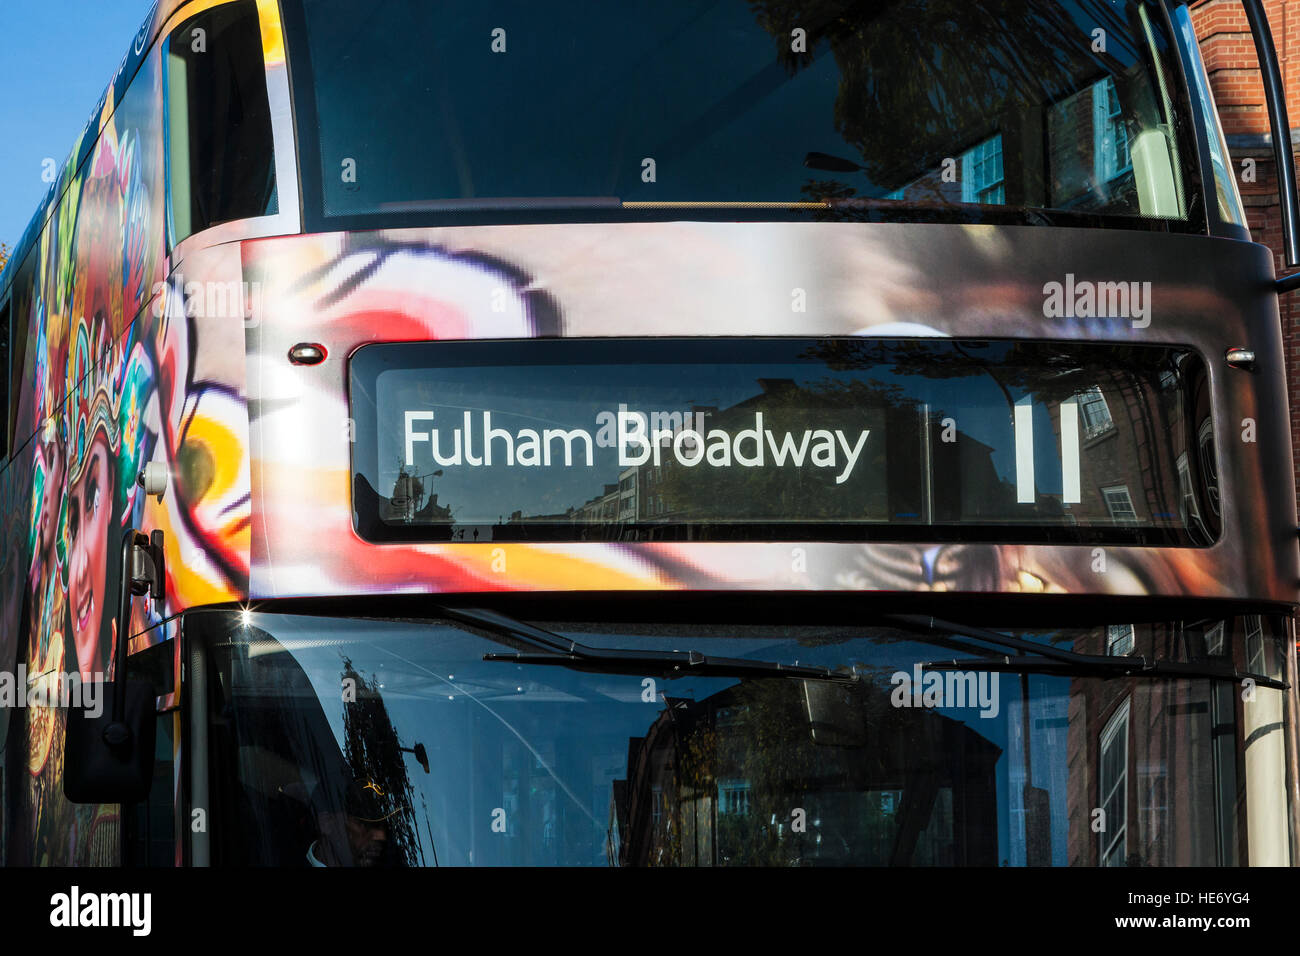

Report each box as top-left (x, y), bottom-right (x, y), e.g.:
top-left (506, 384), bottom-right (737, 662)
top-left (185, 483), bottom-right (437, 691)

top-left (1066, 615), bottom-right (1263, 866)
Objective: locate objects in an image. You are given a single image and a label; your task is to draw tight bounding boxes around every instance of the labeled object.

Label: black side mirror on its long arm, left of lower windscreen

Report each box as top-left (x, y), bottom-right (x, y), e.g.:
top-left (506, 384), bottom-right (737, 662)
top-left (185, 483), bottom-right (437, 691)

top-left (64, 529), bottom-right (165, 804)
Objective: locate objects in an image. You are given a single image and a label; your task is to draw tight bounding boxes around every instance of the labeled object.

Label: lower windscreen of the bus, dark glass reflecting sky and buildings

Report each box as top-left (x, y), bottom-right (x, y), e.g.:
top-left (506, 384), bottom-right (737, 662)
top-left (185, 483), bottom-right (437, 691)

top-left (197, 613), bottom-right (1291, 866)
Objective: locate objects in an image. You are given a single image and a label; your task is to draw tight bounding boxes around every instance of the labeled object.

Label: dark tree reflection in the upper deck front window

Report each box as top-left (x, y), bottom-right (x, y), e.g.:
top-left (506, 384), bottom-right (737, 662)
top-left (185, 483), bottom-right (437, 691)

top-left (749, 0), bottom-right (1154, 217)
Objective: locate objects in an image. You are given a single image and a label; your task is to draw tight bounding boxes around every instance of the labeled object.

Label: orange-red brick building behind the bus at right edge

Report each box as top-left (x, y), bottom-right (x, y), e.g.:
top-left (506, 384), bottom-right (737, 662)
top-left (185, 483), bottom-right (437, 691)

top-left (1190, 0), bottom-right (1300, 509)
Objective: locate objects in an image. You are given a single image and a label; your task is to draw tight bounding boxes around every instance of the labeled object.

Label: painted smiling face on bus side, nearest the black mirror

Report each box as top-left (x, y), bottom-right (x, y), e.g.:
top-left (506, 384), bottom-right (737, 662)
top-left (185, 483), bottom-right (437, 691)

top-left (68, 432), bottom-right (113, 676)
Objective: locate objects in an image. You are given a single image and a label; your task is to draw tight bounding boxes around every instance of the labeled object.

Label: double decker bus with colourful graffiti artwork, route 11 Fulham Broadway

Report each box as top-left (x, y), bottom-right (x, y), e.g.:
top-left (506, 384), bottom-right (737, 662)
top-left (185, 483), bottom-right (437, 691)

top-left (0, 0), bottom-right (1300, 866)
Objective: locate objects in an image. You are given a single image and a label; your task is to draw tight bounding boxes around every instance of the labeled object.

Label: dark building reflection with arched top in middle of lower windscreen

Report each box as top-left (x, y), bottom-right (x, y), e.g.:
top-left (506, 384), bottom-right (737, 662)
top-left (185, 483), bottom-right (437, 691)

top-left (607, 680), bottom-right (1001, 866)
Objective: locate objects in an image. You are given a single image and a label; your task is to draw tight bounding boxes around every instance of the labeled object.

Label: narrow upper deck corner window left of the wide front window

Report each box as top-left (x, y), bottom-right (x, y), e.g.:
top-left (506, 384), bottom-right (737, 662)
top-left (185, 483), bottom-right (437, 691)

top-left (166, 0), bottom-right (278, 246)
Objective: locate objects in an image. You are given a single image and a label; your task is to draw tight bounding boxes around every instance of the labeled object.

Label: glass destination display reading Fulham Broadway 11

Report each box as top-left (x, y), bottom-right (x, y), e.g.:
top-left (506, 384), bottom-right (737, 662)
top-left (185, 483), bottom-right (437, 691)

top-left (350, 338), bottom-right (1218, 546)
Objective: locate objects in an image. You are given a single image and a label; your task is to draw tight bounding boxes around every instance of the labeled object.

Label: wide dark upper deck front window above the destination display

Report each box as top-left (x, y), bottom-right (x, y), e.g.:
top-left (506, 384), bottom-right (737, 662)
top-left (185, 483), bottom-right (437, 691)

top-left (286, 0), bottom-right (1204, 229)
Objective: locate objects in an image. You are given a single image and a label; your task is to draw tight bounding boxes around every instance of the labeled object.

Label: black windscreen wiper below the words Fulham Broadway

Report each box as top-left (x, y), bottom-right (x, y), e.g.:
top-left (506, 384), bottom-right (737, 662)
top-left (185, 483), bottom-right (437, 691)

top-left (442, 607), bottom-right (858, 684)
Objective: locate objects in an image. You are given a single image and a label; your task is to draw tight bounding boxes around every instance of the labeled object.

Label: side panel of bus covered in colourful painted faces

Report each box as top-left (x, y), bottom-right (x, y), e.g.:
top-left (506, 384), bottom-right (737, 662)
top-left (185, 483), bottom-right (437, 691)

top-left (7, 39), bottom-right (166, 865)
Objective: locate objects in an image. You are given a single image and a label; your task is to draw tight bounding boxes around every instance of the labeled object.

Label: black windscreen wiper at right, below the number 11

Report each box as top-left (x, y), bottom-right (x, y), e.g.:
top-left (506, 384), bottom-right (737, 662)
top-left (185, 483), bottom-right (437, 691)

top-left (884, 614), bottom-right (1291, 691)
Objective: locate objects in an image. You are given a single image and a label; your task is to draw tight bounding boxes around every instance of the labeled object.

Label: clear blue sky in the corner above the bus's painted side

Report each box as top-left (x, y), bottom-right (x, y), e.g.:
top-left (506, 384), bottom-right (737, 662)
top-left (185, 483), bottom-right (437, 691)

top-left (0, 0), bottom-right (153, 248)
